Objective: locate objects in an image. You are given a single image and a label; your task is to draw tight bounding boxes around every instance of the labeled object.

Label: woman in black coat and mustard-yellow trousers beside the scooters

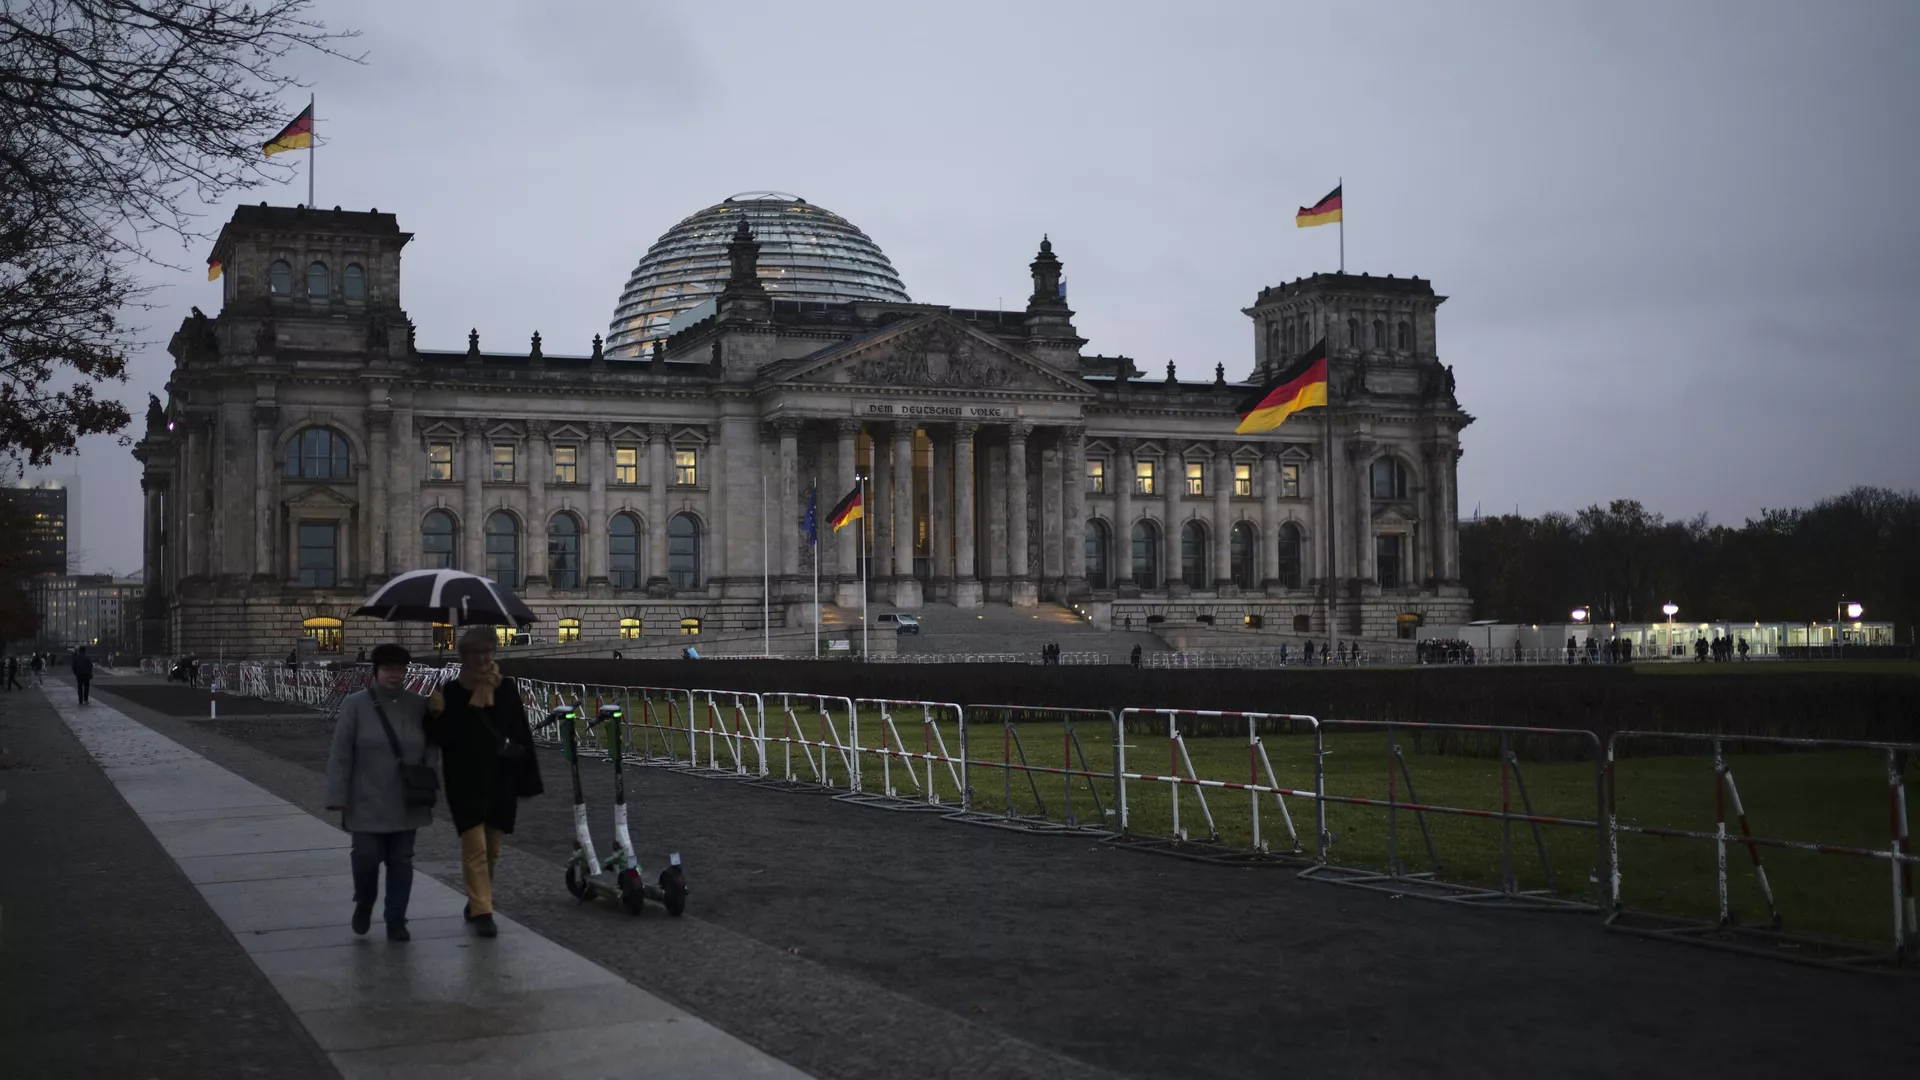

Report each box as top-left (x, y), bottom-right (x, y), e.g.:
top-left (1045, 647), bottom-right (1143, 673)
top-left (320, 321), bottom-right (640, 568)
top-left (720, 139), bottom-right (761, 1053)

top-left (426, 626), bottom-right (541, 938)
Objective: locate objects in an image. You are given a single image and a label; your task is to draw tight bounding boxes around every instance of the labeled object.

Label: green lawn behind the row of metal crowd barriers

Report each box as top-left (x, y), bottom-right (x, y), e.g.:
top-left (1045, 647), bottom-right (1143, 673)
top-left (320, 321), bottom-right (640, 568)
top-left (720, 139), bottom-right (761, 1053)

top-left (552, 684), bottom-right (1920, 942)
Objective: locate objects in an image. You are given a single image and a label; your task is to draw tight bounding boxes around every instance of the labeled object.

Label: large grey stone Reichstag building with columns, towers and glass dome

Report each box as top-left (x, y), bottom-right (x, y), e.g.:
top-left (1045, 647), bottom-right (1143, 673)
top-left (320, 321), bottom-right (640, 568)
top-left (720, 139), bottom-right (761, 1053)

top-left (134, 192), bottom-right (1473, 655)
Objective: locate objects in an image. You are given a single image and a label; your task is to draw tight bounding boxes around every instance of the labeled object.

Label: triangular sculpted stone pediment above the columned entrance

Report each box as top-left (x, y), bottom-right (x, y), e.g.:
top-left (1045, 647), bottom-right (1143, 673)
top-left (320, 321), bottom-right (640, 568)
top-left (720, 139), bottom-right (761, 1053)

top-left (781, 315), bottom-right (1092, 398)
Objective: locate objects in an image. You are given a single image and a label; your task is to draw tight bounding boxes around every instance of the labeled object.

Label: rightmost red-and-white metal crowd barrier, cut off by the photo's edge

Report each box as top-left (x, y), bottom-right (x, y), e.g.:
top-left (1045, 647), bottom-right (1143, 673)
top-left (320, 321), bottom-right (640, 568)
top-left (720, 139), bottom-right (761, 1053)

top-left (1605, 730), bottom-right (1920, 965)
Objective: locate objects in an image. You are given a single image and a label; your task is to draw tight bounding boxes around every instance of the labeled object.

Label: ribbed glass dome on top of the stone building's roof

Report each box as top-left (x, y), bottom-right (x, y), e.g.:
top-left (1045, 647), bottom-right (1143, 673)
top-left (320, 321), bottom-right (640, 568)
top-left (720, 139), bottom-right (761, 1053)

top-left (607, 192), bottom-right (906, 357)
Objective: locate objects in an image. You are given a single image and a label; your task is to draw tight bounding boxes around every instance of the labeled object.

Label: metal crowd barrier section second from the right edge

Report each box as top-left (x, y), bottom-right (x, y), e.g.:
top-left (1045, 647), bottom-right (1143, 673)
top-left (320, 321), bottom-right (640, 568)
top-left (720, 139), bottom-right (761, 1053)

top-left (1302, 721), bottom-right (1607, 911)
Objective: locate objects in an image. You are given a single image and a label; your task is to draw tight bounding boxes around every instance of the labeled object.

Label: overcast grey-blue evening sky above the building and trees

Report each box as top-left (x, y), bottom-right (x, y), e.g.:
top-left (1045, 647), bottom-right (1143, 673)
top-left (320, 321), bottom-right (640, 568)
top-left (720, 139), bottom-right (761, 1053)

top-left (33, 0), bottom-right (1920, 573)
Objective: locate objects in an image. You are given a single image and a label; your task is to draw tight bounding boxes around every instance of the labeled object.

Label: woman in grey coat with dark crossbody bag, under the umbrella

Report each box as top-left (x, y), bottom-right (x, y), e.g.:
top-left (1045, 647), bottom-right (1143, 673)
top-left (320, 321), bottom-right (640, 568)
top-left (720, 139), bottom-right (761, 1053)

top-left (326, 646), bottom-right (438, 942)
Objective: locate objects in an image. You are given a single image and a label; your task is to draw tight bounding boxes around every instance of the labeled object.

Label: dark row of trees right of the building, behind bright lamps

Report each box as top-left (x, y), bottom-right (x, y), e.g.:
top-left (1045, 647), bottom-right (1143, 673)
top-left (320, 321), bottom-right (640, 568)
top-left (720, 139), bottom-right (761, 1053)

top-left (1459, 488), bottom-right (1920, 642)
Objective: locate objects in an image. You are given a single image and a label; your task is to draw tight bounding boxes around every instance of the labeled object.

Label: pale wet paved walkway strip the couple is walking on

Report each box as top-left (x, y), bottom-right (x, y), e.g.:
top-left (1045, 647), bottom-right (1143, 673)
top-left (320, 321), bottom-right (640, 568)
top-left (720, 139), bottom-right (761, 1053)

top-left (43, 687), bottom-right (804, 1080)
